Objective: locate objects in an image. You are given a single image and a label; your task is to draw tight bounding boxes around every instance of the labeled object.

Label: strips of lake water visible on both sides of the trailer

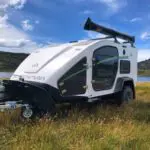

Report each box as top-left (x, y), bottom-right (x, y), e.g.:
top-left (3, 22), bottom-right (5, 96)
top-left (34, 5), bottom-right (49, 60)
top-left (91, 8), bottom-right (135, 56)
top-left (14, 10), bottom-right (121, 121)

top-left (0, 72), bottom-right (150, 82)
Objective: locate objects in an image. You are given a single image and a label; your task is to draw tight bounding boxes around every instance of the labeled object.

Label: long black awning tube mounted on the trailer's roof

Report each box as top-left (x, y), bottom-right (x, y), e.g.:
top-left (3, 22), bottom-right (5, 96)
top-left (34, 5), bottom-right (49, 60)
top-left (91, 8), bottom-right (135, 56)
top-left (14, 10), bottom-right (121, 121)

top-left (84, 18), bottom-right (135, 46)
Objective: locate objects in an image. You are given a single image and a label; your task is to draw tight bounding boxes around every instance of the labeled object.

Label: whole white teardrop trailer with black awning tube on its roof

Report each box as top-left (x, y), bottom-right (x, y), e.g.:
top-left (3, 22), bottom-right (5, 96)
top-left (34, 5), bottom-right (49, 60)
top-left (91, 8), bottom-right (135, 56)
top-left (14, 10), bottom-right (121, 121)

top-left (0, 18), bottom-right (137, 118)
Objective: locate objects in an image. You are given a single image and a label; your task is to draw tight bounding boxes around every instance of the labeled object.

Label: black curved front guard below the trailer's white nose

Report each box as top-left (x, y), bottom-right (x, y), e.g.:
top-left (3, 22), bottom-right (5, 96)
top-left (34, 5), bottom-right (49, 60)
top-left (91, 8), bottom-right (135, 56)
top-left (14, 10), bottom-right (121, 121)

top-left (0, 80), bottom-right (54, 110)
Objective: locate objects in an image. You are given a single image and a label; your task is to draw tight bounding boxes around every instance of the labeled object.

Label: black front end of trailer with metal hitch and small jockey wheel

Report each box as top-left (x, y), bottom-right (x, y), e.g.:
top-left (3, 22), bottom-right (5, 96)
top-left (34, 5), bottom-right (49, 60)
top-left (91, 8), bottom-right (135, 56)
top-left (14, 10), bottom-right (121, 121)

top-left (0, 80), bottom-right (53, 119)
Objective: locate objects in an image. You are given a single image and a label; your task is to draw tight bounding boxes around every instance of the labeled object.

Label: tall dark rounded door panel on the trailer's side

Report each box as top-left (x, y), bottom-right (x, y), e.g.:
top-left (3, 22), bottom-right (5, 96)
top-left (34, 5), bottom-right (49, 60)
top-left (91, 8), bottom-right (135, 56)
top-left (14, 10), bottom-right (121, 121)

top-left (92, 45), bottom-right (119, 91)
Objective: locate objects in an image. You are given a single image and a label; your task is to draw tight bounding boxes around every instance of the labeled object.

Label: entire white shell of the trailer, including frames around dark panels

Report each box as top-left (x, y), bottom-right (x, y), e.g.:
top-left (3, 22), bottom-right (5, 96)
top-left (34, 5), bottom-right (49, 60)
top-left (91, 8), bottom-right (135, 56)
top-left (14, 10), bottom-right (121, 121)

top-left (11, 40), bottom-right (137, 97)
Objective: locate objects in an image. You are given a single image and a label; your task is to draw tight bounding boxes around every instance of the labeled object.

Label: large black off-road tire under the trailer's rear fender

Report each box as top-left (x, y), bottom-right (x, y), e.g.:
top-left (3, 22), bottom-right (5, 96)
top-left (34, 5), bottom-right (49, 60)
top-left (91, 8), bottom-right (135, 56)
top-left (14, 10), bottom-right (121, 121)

top-left (117, 85), bottom-right (134, 105)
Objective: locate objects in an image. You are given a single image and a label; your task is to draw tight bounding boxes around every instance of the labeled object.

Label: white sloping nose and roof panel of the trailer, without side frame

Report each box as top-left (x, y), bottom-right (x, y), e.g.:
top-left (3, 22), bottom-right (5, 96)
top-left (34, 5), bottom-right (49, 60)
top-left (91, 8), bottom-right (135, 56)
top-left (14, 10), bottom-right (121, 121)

top-left (11, 41), bottom-right (96, 87)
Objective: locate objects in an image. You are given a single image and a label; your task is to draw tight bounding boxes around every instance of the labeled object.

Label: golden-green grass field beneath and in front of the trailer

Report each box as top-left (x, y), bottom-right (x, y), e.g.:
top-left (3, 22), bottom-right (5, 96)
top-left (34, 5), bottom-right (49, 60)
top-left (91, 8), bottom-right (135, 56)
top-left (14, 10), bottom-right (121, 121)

top-left (0, 83), bottom-right (150, 150)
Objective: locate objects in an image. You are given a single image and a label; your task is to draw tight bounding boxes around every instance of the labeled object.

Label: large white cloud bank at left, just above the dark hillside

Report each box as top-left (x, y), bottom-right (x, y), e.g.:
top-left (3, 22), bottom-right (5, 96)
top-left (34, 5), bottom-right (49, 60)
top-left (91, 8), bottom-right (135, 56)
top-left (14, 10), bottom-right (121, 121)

top-left (0, 15), bottom-right (38, 52)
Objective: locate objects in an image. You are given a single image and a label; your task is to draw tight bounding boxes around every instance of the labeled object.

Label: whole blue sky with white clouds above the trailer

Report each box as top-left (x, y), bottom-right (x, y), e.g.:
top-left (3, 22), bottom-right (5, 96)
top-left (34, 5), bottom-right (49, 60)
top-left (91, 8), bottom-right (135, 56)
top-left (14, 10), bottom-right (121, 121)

top-left (0, 0), bottom-right (150, 61)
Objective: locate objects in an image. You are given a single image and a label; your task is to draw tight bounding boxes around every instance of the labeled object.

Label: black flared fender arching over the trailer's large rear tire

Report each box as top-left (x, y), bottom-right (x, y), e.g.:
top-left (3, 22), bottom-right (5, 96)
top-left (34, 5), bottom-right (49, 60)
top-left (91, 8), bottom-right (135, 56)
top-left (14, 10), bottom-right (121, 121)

top-left (114, 77), bottom-right (135, 98)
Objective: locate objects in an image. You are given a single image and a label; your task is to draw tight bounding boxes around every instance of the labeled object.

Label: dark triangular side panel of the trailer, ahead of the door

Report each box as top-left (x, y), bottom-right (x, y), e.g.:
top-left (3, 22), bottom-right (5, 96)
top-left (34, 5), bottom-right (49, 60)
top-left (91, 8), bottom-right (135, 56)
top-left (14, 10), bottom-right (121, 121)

top-left (58, 57), bottom-right (87, 97)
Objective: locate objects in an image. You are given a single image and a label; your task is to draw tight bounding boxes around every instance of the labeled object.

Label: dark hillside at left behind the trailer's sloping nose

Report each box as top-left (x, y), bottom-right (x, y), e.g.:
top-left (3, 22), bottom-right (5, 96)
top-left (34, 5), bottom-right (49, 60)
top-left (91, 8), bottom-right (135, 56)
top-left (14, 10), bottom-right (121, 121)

top-left (0, 52), bottom-right (28, 72)
